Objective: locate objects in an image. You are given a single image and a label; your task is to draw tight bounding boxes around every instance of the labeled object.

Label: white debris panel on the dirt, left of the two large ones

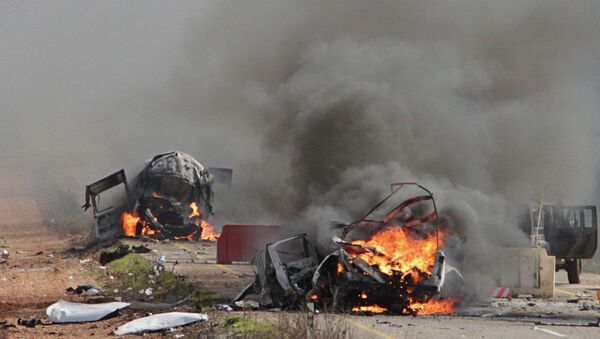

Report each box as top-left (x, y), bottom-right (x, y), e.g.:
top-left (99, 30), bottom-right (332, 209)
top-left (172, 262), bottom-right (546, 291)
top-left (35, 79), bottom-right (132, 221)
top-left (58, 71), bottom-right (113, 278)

top-left (46, 299), bottom-right (129, 323)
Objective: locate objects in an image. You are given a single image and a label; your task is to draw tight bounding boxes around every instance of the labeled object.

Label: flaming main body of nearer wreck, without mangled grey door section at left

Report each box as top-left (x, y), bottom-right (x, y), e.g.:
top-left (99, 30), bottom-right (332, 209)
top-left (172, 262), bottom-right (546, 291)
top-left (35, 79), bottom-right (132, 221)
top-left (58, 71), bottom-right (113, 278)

top-left (310, 183), bottom-right (454, 315)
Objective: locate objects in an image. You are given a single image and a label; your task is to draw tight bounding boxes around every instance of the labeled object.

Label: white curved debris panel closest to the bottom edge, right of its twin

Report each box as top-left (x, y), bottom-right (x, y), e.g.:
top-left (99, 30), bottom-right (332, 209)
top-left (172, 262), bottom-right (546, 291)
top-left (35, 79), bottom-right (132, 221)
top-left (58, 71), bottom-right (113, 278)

top-left (113, 312), bottom-right (208, 335)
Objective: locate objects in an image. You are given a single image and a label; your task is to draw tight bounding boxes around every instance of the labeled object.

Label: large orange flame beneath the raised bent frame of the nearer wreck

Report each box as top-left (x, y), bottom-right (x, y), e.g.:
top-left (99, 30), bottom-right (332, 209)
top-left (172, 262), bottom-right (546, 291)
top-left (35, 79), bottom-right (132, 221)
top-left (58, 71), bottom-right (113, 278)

top-left (352, 226), bottom-right (442, 282)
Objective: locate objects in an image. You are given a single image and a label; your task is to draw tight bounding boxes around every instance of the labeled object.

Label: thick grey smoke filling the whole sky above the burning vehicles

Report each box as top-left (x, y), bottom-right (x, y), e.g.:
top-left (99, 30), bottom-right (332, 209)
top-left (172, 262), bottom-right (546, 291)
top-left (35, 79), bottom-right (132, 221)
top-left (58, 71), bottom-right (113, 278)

top-left (0, 0), bottom-right (600, 294)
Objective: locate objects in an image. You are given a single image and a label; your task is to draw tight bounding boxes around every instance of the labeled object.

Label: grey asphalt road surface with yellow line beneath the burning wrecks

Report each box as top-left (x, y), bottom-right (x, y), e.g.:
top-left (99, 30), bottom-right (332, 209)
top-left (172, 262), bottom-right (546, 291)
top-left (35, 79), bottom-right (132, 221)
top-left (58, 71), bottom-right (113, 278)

top-left (128, 240), bottom-right (600, 338)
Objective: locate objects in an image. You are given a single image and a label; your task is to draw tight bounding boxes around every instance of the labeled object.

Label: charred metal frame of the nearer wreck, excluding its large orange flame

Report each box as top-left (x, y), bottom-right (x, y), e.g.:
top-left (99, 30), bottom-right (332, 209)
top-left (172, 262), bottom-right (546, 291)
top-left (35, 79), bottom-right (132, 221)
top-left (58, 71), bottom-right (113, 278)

top-left (235, 183), bottom-right (462, 315)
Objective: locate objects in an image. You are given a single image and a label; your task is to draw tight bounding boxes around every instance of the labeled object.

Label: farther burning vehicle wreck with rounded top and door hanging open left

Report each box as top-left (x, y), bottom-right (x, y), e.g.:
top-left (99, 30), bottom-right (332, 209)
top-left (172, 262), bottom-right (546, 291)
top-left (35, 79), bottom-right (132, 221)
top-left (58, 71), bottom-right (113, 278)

top-left (83, 152), bottom-right (233, 240)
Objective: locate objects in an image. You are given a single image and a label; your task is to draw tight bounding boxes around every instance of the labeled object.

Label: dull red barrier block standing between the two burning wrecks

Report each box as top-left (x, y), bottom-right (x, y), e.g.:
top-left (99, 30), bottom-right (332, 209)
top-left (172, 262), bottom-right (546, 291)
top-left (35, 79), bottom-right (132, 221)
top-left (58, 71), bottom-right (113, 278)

top-left (217, 225), bottom-right (281, 264)
